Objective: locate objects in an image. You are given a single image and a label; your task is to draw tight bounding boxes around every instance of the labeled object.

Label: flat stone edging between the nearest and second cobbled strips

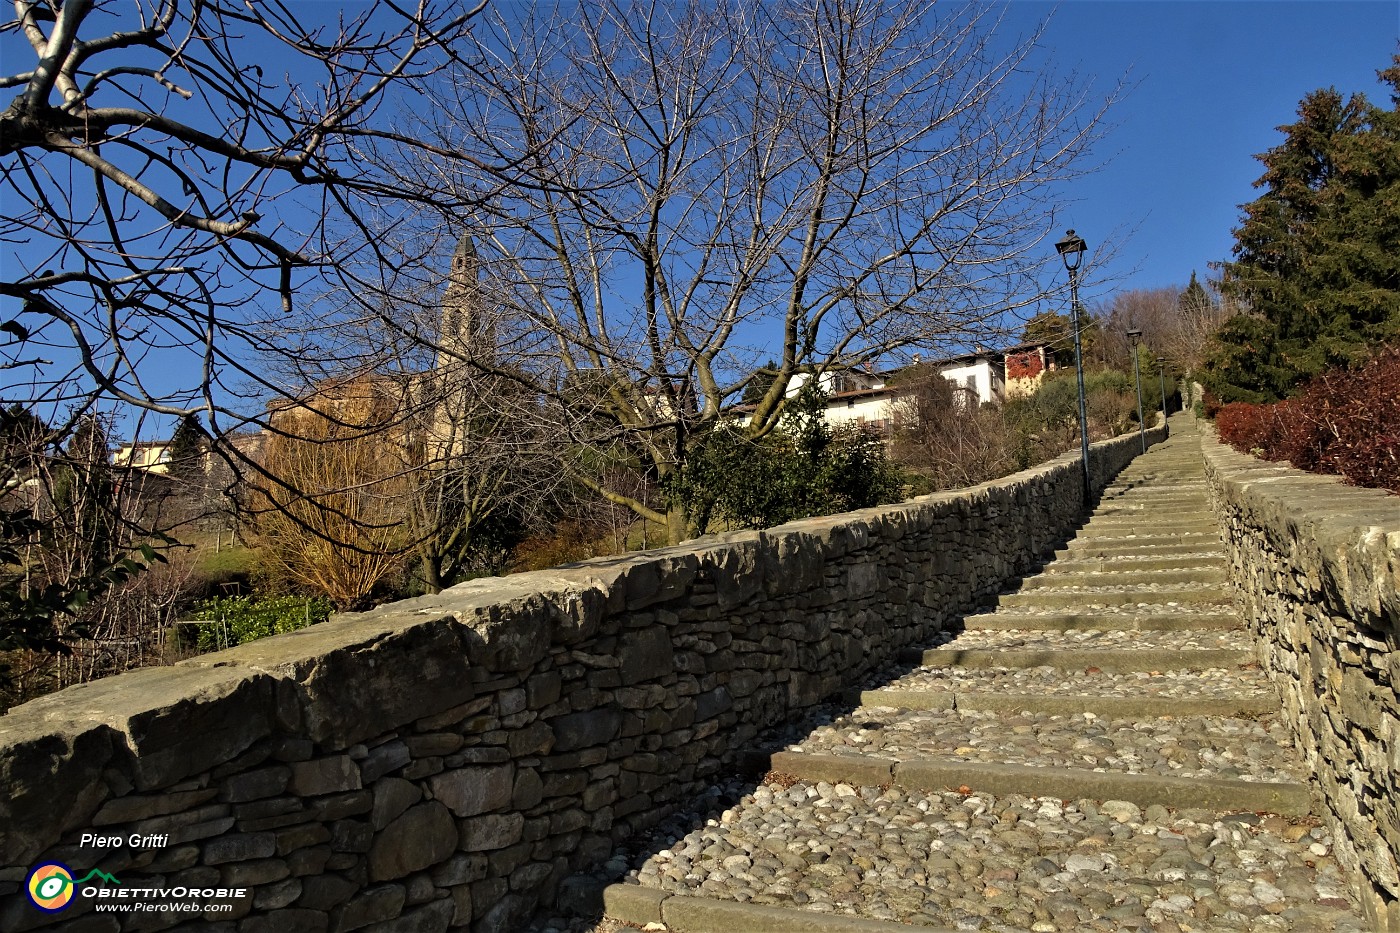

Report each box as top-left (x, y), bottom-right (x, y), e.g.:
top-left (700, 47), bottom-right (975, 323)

top-left (771, 752), bottom-right (1312, 817)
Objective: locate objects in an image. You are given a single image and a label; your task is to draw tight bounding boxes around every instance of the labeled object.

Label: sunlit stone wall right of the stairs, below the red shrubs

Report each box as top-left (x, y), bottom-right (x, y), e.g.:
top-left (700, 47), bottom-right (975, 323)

top-left (1201, 429), bottom-right (1400, 933)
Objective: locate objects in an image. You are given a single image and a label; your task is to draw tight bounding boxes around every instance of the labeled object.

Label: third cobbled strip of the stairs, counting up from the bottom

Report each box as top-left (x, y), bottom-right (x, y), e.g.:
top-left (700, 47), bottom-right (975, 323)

top-left (889, 667), bottom-right (1274, 699)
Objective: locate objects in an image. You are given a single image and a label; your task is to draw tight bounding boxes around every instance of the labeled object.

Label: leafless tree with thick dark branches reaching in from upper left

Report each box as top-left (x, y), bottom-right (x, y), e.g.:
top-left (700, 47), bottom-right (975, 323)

top-left (0, 0), bottom-right (482, 633)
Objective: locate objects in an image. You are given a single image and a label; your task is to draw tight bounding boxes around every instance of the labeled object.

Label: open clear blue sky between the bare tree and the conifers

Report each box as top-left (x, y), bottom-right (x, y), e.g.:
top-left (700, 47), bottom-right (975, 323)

top-left (1011, 0), bottom-right (1400, 289)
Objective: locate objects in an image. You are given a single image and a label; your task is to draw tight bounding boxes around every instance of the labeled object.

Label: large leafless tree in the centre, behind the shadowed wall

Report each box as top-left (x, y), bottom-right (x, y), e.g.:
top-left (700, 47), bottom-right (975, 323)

top-left (378, 0), bottom-right (1107, 541)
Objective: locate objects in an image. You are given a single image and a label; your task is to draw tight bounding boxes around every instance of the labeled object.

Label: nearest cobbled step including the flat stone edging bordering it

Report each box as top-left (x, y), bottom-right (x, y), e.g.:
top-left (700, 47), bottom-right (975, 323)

top-left (603, 778), bottom-right (1366, 933)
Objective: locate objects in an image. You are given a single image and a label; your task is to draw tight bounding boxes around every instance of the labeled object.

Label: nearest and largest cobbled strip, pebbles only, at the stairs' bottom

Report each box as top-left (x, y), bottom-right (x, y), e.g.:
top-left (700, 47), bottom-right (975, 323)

top-left (629, 783), bottom-right (1365, 933)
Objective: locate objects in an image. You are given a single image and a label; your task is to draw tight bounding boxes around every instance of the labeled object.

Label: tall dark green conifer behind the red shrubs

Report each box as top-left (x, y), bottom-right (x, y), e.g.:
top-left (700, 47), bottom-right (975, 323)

top-left (1205, 56), bottom-right (1400, 401)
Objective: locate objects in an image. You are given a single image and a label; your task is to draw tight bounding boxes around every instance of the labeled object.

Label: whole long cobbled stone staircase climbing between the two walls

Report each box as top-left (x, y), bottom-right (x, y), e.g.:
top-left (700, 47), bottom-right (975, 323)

top-left (598, 416), bottom-right (1365, 933)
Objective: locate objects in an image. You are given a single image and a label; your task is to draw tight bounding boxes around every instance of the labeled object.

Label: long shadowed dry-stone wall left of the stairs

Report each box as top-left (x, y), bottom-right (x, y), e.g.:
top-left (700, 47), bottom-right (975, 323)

top-left (0, 424), bottom-right (1166, 933)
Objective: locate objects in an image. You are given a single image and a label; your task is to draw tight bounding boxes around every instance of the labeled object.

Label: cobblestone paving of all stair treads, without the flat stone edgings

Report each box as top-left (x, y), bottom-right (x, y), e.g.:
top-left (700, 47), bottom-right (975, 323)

top-left (557, 416), bottom-right (1366, 933)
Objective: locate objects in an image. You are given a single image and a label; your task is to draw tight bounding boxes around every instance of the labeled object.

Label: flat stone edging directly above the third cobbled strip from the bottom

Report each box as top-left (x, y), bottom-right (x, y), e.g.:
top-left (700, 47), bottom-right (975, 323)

top-left (900, 647), bottom-right (1254, 674)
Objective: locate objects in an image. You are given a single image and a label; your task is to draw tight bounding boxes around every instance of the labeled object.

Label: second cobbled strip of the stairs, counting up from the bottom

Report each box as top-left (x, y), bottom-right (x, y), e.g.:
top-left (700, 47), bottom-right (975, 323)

top-left (788, 706), bottom-right (1308, 782)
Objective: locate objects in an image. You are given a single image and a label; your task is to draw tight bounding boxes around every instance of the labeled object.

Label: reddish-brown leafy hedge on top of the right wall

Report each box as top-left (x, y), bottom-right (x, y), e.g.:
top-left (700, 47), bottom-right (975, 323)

top-left (1215, 347), bottom-right (1400, 493)
